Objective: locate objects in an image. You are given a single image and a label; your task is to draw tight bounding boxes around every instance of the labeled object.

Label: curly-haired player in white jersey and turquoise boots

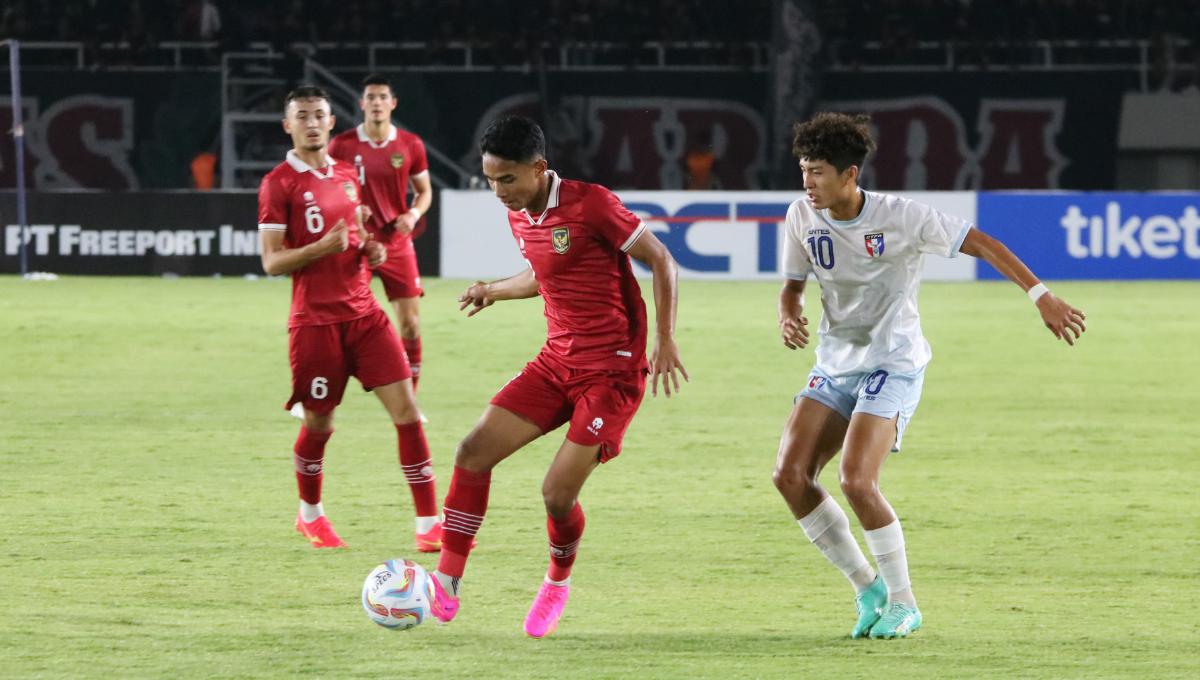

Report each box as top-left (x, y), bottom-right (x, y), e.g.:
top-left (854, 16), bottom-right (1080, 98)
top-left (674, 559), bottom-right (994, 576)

top-left (774, 113), bottom-right (1085, 638)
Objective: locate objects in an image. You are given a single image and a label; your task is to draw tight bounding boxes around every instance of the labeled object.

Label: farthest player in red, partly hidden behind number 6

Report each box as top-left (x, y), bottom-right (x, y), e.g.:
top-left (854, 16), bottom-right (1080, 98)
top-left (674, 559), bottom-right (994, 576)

top-left (329, 76), bottom-right (433, 391)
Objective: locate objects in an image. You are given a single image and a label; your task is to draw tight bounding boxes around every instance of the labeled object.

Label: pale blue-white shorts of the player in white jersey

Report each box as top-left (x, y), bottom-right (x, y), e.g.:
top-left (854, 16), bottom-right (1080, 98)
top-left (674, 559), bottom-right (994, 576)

top-left (796, 367), bottom-right (925, 451)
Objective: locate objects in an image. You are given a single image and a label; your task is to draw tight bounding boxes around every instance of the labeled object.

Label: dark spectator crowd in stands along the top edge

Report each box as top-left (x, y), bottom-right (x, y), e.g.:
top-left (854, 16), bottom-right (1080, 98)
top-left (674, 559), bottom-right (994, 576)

top-left (0, 0), bottom-right (1200, 72)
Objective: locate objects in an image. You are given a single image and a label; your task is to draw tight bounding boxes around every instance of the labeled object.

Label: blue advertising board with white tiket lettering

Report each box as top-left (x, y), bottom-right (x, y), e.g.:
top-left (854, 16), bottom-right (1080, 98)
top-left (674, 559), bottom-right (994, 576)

top-left (976, 192), bottom-right (1200, 279)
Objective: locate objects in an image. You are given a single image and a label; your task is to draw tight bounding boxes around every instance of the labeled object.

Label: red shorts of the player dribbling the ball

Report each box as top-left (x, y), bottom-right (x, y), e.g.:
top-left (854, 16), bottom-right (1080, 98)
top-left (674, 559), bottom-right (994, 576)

top-left (492, 354), bottom-right (646, 463)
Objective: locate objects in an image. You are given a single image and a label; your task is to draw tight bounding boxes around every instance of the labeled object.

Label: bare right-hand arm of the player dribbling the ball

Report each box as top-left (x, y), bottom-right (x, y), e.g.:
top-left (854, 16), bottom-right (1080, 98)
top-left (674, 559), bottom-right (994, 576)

top-left (626, 229), bottom-right (690, 398)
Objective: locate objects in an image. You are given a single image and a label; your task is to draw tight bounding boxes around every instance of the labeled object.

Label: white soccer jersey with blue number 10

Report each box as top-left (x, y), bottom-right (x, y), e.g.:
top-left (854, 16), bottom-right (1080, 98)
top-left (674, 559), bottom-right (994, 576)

top-left (784, 191), bottom-right (971, 377)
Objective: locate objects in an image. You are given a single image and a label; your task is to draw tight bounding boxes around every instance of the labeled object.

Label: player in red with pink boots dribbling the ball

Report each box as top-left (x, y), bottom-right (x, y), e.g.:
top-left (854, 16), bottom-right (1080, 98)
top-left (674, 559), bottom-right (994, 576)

top-left (433, 116), bottom-right (688, 637)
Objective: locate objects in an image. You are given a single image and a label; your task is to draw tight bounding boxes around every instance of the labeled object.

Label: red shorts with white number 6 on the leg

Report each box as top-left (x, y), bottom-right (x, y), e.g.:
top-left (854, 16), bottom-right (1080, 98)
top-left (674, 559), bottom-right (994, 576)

top-left (283, 309), bottom-right (413, 414)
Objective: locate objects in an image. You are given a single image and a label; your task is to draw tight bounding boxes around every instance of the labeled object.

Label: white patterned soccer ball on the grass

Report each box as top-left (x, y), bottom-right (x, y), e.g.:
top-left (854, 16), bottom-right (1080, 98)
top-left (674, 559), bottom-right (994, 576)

top-left (362, 558), bottom-right (433, 631)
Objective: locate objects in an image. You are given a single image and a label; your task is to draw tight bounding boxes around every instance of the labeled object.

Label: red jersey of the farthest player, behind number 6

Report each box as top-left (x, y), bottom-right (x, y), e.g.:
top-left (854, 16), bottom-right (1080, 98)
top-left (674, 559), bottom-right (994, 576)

top-left (329, 125), bottom-right (430, 242)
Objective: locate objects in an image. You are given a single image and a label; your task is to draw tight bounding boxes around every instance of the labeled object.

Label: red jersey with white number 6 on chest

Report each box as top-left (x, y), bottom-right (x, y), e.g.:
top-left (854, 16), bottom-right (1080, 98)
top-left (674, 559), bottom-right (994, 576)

top-left (258, 151), bottom-right (379, 327)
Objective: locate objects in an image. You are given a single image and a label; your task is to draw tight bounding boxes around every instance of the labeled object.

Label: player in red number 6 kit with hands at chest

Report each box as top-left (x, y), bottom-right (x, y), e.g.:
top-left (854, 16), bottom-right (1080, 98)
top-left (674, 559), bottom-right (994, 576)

top-left (258, 86), bottom-right (442, 552)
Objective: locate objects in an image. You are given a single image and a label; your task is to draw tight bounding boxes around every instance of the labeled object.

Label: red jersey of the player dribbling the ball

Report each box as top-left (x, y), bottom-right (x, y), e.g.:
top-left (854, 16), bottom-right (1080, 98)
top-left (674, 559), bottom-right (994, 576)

top-left (509, 173), bottom-right (647, 371)
